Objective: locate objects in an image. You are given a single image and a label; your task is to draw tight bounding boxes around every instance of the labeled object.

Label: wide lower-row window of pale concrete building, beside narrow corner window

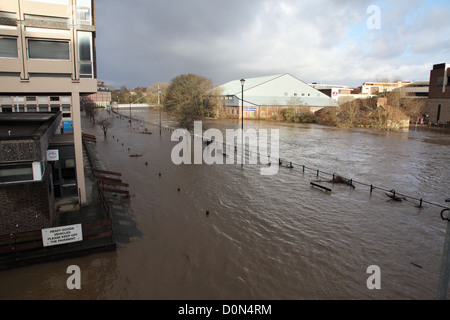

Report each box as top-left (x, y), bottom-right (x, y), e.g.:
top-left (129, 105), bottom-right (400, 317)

top-left (27, 39), bottom-right (70, 60)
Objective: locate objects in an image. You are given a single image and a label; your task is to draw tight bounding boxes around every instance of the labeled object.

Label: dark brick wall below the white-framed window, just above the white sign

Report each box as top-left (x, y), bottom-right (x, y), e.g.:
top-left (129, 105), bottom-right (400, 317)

top-left (0, 167), bottom-right (54, 234)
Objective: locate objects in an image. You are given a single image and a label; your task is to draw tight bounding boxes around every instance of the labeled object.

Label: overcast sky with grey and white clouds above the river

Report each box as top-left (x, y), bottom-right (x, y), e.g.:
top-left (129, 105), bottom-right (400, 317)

top-left (96, 0), bottom-right (450, 88)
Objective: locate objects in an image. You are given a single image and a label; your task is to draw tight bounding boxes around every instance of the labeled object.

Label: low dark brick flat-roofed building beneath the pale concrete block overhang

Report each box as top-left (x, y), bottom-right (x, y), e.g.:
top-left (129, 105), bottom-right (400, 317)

top-left (0, 112), bottom-right (62, 235)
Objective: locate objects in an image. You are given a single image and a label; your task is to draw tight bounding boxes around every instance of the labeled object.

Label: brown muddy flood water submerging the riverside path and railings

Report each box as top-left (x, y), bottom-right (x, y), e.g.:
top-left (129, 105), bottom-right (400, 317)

top-left (0, 111), bottom-right (450, 300)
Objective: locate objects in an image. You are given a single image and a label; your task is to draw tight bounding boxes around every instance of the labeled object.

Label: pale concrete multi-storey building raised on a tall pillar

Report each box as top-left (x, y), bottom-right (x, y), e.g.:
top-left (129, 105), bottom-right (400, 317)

top-left (0, 0), bottom-right (97, 204)
